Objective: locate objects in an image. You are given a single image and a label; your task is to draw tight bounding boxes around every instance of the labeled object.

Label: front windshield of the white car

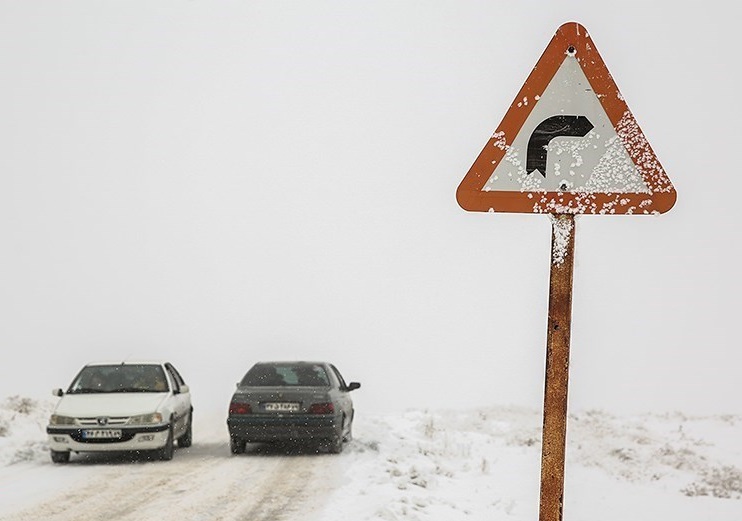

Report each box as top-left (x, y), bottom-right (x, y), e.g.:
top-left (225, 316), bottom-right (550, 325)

top-left (67, 364), bottom-right (168, 394)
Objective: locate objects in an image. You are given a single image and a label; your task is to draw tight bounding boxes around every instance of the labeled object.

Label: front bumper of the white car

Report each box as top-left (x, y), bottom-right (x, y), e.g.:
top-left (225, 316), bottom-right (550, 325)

top-left (46, 424), bottom-right (170, 452)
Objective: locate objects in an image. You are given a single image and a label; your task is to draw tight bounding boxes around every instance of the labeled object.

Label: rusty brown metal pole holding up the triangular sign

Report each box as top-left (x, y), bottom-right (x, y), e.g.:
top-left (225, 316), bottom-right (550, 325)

top-left (539, 214), bottom-right (575, 521)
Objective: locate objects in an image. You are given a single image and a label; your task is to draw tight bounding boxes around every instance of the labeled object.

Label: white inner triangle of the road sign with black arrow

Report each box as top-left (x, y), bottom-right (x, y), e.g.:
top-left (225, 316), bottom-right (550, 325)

top-left (482, 55), bottom-right (651, 194)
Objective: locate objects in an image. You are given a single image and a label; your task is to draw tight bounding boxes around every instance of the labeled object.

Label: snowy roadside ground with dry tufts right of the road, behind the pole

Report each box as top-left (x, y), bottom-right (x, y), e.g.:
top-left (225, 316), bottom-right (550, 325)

top-left (328, 407), bottom-right (742, 520)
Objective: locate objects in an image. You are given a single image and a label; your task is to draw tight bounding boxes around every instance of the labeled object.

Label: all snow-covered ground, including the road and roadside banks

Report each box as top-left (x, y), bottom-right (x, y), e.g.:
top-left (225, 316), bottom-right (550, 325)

top-left (0, 396), bottom-right (742, 521)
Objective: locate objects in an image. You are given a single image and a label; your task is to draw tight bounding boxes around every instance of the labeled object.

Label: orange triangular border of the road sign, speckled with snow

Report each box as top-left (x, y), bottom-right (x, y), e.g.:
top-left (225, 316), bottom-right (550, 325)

top-left (456, 22), bottom-right (677, 214)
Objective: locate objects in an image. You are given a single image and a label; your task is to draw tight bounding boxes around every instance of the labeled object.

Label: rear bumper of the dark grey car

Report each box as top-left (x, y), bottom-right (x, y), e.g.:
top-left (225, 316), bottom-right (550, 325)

top-left (227, 414), bottom-right (341, 443)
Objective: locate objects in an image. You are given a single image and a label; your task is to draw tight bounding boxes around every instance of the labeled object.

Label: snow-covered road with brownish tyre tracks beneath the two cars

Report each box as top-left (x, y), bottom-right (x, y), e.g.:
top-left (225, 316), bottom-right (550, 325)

top-left (0, 426), bottom-right (342, 521)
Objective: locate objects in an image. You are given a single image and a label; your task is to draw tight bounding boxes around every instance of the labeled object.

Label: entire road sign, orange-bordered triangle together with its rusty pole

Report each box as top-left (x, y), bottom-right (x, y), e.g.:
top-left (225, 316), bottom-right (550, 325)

top-left (456, 22), bottom-right (677, 521)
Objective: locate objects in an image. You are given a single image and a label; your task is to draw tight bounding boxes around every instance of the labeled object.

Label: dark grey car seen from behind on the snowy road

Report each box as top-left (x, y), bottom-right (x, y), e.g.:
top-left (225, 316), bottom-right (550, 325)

top-left (227, 362), bottom-right (361, 454)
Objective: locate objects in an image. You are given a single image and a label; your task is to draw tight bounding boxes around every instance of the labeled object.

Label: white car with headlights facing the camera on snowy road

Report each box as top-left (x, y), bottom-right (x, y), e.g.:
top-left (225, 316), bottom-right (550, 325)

top-left (46, 360), bottom-right (193, 463)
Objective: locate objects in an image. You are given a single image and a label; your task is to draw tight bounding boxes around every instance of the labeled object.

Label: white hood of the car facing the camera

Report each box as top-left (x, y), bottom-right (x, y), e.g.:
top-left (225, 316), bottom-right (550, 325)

top-left (54, 393), bottom-right (168, 418)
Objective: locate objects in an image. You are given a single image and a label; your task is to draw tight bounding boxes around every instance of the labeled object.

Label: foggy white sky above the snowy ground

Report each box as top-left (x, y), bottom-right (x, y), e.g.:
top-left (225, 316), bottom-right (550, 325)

top-left (0, 0), bottom-right (742, 413)
